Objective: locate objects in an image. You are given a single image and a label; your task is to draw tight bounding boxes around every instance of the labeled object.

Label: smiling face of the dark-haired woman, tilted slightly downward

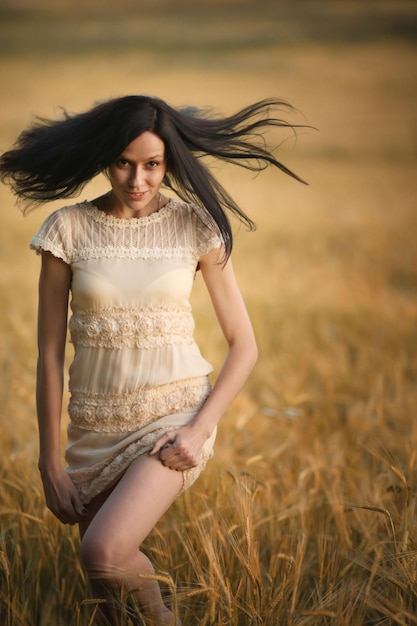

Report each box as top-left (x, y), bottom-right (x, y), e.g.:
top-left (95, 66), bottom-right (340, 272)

top-left (107, 131), bottom-right (166, 217)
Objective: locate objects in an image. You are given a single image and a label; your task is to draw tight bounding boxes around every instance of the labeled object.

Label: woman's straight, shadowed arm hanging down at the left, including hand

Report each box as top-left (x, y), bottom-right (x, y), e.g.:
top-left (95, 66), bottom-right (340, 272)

top-left (36, 252), bottom-right (83, 524)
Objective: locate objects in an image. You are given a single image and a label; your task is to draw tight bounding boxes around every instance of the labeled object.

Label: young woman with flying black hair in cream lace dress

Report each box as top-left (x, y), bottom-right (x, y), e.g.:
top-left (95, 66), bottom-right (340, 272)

top-left (0, 96), bottom-right (306, 626)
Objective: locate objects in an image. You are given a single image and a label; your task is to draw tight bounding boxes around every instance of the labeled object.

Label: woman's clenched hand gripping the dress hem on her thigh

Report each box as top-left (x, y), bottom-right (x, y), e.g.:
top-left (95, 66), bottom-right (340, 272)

top-left (149, 424), bottom-right (207, 472)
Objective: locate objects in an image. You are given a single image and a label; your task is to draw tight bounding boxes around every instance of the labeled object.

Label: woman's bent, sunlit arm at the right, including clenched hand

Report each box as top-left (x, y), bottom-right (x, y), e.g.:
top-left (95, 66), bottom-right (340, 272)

top-left (151, 250), bottom-right (258, 470)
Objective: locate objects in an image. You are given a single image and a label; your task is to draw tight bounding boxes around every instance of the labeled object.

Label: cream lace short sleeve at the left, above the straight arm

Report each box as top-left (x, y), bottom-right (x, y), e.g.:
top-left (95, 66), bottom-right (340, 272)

top-left (29, 209), bottom-right (71, 264)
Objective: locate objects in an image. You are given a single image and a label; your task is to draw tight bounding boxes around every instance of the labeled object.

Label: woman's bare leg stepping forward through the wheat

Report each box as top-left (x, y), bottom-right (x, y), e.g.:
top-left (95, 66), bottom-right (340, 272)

top-left (80, 455), bottom-right (182, 626)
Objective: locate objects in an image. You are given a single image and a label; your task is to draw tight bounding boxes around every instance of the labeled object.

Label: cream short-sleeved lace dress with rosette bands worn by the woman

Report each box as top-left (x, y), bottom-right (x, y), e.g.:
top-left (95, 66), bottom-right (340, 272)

top-left (30, 200), bottom-right (222, 503)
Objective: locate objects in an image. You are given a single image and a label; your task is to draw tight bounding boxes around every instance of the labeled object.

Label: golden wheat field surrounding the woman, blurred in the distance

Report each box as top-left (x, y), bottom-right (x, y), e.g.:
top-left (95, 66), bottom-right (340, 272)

top-left (0, 0), bottom-right (417, 626)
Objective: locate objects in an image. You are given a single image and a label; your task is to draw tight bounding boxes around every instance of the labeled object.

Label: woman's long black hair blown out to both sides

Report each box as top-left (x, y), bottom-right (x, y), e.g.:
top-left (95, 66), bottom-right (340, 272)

top-left (0, 96), bottom-right (304, 256)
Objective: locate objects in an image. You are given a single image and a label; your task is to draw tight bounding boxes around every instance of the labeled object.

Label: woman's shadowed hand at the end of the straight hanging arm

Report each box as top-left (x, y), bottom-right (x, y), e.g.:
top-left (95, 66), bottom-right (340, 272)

top-left (41, 467), bottom-right (87, 524)
